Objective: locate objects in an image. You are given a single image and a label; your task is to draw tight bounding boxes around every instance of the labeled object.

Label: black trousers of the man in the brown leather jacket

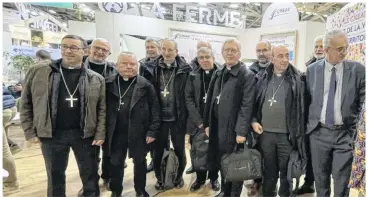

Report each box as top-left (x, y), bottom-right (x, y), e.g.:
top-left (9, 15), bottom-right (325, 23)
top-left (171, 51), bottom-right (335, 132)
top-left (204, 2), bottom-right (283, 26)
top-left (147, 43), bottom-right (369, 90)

top-left (40, 130), bottom-right (100, 197)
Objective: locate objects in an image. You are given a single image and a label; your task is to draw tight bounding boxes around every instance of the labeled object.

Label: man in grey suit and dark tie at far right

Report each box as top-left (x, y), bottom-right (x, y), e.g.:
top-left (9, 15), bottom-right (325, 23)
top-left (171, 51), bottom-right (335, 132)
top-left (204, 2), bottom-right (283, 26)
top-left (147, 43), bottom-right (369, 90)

top-left (306, 30), bottom-right (365, 197)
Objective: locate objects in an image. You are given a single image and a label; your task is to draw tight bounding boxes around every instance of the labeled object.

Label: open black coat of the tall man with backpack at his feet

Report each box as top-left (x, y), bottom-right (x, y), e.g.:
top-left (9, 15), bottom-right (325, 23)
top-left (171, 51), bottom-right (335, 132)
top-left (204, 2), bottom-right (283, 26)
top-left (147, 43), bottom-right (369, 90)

top-left (140, 55), bottom-right (192, 133)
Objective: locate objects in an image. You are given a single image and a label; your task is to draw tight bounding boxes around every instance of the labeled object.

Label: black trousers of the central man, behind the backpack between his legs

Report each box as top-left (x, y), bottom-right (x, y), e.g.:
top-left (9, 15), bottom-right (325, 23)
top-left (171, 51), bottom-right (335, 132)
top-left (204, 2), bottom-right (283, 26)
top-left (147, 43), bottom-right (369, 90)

top-left (154, 122), bottom-right (186, 182)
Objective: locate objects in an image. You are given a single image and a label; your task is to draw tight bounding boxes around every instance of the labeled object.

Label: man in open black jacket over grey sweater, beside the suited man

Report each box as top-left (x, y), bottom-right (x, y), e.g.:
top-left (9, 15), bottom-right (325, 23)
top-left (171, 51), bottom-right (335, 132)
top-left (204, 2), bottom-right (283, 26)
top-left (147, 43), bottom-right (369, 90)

top-left (252, 46), bottom-right (305, 197)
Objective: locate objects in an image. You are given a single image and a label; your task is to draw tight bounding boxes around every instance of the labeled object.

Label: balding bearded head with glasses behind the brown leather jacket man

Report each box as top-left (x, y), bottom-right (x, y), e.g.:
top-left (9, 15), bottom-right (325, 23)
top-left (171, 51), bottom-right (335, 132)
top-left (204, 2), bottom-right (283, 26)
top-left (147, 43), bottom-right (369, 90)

top-left (88, 38), bottom-right (111, 63)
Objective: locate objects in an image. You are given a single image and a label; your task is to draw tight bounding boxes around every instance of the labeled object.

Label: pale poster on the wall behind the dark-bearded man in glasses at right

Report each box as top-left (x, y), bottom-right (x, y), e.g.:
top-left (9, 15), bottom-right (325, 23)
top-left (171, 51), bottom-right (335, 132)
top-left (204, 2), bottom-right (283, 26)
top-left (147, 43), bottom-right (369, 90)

top-left (260, 31), bottom-right (297, 66)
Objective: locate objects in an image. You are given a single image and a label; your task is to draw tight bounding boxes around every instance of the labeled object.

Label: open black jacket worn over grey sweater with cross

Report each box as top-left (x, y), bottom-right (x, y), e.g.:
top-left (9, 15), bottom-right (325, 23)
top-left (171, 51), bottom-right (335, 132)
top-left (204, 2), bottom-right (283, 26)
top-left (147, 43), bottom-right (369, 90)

top-left (253, 64), bottom-right (306, 158)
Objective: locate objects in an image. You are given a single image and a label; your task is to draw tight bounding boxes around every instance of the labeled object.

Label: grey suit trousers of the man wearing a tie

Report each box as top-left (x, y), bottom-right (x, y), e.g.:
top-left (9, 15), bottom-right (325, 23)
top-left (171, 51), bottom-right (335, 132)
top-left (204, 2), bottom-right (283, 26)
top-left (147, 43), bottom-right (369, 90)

top-left (310, 127), bottom-right (353, 197)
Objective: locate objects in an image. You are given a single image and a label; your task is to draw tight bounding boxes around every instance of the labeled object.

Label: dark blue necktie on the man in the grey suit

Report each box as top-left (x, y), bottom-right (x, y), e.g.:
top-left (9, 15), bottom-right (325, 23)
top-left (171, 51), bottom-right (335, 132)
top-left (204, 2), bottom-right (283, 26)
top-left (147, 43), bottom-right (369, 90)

top-left (325, 67), bottom-right (336, 127)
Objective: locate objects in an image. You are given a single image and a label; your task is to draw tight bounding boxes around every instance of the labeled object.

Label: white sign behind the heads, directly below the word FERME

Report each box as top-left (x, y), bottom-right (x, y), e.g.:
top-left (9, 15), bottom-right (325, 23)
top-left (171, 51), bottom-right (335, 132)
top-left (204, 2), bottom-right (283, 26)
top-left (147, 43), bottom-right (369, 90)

top-left (171, 29), bottom-right (237, 64)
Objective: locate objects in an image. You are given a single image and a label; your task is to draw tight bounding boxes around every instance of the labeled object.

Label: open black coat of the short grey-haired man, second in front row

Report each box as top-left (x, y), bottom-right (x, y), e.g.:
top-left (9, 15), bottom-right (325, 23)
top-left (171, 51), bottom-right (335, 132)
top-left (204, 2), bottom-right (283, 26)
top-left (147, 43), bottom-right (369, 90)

top-left (106, 74), bottom-right (161, 155)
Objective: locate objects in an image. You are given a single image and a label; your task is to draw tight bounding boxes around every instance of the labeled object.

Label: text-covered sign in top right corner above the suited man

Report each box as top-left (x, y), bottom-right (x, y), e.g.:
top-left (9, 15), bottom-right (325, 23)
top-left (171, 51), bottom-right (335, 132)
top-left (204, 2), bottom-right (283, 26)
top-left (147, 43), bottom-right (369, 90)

top-left (326, 3), bottom-right (366, 64)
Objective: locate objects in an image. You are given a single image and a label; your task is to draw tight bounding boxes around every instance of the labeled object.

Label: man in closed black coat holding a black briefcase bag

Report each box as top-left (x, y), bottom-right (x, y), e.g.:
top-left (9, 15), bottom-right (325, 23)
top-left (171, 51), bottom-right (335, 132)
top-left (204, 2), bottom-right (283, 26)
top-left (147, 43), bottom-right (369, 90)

top-left (204, 39), bottom-right (255, 197)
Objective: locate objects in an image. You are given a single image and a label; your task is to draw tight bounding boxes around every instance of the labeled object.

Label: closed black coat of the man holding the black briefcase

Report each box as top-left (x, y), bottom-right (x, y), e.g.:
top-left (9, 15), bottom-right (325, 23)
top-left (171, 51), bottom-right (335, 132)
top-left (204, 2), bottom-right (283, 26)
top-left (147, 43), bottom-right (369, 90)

top-left (204, 62), bottom-right (255, 159)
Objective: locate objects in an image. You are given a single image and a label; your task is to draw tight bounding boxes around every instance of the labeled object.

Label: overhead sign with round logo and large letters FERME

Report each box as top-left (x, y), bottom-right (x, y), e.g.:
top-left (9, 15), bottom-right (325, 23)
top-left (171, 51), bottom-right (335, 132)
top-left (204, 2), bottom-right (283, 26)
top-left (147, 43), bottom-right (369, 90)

top-left (98, 2), bottom-right (246, 29)
